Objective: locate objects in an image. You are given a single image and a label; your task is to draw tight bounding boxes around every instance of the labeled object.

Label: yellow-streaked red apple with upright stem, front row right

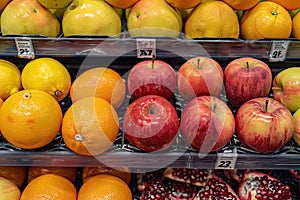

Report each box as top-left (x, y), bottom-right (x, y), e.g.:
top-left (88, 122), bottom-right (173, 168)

top-left (236, 97), bottom-right (294, 153)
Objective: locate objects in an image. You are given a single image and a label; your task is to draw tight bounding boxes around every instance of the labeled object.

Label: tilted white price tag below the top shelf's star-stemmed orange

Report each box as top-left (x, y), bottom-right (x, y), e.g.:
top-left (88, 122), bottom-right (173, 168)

top-left (269, 41), bottom-right (290, 62)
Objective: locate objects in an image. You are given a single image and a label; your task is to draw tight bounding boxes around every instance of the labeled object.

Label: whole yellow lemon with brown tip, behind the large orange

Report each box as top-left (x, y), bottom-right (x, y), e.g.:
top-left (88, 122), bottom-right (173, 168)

top-left (21, 58), bottom-right (71, 101)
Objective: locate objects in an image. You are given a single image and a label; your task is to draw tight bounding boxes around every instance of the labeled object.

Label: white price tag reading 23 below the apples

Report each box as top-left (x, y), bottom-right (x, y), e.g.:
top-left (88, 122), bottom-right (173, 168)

top-left (215, 148), bottom-right (238, 169)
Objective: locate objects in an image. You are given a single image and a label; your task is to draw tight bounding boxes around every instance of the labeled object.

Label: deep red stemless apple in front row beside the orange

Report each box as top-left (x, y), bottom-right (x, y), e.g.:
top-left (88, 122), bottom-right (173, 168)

top-left (123, 95), bottom-right (179, 152)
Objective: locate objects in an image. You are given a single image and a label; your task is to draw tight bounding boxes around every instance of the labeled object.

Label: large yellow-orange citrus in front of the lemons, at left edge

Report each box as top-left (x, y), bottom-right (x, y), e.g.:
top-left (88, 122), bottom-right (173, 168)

top-left (0, 90), bottom-right (62, 149)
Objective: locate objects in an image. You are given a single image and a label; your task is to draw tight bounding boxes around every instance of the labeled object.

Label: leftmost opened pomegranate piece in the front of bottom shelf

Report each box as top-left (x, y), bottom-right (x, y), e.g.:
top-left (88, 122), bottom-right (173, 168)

top-left (140, 178), bottom-right (198, 200)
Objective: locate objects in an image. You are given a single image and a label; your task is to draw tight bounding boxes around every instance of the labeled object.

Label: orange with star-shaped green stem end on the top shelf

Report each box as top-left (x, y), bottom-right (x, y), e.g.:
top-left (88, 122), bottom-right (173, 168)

top-left (241, 1), bottom-right (292, 40)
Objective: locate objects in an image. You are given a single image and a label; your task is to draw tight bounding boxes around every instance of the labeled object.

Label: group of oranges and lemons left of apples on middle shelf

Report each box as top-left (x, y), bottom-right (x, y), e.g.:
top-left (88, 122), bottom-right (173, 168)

top-left (0, 57), bottom-right (126, 156)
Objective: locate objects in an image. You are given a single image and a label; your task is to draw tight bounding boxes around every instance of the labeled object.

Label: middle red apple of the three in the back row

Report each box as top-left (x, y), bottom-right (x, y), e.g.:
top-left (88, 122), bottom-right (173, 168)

top-left (177, 56), bottom-right (223, 100)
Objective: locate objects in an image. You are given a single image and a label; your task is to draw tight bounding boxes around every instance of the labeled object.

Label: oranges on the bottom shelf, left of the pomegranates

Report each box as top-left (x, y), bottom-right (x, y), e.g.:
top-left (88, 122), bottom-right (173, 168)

top-left (0, 166), bottom-right (132, 200)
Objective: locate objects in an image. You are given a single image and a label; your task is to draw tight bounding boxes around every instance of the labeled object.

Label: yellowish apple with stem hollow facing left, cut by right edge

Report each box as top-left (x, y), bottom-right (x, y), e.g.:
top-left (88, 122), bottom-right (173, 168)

top-left (272, 67), bottom-right (300, 112)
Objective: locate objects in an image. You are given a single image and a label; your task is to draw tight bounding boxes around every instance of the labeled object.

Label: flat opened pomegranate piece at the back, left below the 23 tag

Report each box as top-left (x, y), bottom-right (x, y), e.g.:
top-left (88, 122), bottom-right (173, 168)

top-left (164, 168), bottom-right (212, 186)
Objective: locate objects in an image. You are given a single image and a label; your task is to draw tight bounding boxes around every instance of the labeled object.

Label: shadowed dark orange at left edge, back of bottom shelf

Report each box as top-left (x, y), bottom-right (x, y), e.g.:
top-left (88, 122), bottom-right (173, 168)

top-left (0, 166), bottom-right (27, 188)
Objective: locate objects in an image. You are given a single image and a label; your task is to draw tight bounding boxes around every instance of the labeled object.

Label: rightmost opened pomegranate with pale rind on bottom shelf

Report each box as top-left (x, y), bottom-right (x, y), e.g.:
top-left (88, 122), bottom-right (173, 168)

top-left (238, 171), bottom-right (292, 200)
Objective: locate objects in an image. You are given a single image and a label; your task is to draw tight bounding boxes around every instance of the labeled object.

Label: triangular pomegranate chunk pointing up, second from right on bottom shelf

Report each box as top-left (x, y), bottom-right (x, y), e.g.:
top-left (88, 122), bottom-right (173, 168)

top-left (194, 175), bottom-right (240, 200)
